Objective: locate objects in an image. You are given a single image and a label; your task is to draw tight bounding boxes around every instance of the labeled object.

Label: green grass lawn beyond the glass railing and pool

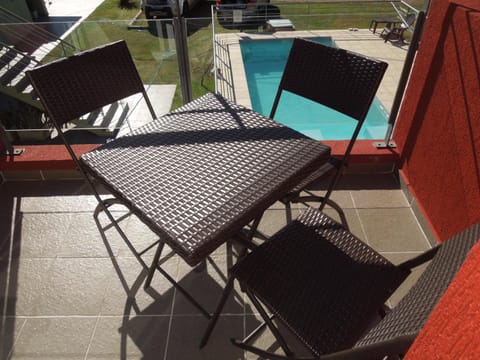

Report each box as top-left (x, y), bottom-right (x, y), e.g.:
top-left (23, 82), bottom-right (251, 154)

top-left (48, 0), bottom-right (423, 108)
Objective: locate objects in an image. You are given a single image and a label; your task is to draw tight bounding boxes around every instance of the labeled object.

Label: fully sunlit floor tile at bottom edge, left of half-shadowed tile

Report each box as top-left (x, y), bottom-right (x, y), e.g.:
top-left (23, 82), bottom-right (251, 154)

top-left (11, 317), bottom-right (97, 360)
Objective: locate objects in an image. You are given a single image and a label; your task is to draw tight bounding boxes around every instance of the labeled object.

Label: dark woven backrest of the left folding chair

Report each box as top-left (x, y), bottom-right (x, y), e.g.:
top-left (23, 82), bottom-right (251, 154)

top-left (28, 41), bottom-right (143, 126)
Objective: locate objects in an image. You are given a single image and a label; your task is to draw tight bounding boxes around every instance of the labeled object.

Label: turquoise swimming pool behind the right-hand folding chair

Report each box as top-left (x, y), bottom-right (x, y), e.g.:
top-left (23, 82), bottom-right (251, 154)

top-left (240, 37), bottom-right (388, 140)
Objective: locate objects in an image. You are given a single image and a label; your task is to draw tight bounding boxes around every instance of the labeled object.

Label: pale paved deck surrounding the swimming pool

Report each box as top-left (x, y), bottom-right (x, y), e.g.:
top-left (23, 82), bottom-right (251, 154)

top-left (216, 29), bottom-right (408, 112)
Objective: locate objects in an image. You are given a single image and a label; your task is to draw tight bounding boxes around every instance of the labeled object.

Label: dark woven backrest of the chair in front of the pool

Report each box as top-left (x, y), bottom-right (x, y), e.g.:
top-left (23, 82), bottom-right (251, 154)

top-left (280, 39), bottom-right (387, 120)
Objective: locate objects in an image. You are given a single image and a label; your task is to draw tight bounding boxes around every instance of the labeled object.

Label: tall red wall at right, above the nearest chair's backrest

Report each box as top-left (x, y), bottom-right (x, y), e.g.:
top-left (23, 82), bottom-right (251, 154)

top-left (394, 0), bottom-right (480, 241)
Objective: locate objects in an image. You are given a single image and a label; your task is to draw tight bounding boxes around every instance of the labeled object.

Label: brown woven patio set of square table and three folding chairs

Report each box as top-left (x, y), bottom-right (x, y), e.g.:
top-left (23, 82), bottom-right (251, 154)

top-left (29, 39), bottom-right (480, 359)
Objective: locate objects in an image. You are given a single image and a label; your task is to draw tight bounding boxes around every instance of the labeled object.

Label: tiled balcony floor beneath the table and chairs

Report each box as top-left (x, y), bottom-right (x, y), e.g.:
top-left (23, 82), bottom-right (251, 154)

top-left (0, 174), bottom-right (430, 360)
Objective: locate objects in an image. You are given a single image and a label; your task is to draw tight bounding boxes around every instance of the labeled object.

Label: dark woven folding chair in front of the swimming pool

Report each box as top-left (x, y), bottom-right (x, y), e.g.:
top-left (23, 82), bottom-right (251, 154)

top-left (270, 38), bottom-right (388, 225)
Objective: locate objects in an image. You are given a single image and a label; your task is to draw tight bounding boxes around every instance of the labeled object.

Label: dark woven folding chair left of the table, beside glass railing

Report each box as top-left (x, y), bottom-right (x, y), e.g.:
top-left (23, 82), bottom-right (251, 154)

top-left (27, 40), bottom-right (210, 318)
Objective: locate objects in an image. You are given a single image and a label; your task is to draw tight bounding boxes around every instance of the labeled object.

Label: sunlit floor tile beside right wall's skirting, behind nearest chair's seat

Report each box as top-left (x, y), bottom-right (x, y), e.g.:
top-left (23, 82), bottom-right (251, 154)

top-left (357, 208), bottom-right (429, 252)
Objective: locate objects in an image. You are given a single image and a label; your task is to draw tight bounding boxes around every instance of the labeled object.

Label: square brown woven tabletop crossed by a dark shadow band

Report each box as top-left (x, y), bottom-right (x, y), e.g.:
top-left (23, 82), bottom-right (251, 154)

top-left (82, 94), bottom-right (330, 265)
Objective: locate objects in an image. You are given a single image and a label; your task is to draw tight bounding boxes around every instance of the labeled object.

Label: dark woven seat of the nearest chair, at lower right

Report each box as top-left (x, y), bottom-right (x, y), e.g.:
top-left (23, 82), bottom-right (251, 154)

top-left (234, 208), bottom-right (409, 355)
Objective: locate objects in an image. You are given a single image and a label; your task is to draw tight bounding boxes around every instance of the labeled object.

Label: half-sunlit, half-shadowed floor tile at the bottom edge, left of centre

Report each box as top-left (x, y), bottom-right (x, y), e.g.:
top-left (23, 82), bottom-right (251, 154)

top-left (86, 316), bottom-right (170, 360)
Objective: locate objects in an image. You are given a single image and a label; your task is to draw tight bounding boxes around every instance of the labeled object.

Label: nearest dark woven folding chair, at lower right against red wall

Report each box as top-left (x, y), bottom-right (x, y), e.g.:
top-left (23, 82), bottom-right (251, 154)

top-left (203, 208), bottom-right (480, 360)
